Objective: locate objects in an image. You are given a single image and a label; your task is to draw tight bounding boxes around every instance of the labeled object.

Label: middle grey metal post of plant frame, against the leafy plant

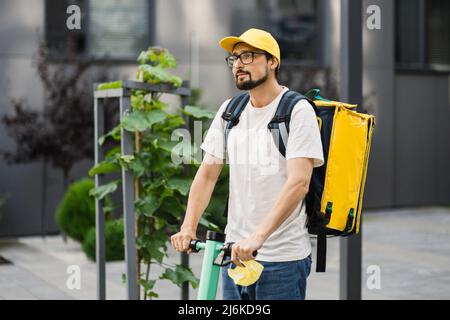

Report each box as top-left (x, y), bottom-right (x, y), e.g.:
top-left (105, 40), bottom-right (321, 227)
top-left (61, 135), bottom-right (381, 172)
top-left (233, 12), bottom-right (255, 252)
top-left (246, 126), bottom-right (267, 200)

top-left (120, 96), bottom-right (138, 300)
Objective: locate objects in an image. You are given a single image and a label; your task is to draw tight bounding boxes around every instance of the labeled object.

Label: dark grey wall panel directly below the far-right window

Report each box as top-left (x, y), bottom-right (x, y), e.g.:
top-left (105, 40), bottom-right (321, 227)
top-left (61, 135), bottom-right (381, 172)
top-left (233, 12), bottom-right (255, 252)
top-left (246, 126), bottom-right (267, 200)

top-left (395, 73), bottom-right (450, 205)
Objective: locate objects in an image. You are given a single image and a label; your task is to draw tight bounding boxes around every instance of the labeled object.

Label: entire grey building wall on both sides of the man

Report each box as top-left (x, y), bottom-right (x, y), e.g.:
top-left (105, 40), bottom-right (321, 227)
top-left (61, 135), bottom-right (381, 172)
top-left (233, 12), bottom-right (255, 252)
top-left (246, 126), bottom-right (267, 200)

top-left (0, 0), bottom-right (450, 236)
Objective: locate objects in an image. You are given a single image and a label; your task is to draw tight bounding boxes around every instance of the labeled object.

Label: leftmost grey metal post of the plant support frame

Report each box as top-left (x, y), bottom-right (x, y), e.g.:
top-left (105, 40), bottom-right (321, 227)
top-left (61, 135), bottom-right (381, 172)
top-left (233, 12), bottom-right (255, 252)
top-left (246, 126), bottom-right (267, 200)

top-left (94, 97), bottom-right (106, 300)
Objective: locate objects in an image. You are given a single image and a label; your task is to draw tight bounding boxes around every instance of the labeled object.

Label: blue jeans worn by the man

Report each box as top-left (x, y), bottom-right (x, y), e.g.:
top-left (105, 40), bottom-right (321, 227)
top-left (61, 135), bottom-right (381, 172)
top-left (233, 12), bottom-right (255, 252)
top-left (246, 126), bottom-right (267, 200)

top-left (222, 255), bottom-right (312, 300)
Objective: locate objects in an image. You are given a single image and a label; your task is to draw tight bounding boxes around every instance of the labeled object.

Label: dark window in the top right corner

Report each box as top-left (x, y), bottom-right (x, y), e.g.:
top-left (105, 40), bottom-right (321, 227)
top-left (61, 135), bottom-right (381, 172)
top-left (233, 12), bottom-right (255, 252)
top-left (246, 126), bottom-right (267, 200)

top-left (396, 0), bottom-right (450, 70)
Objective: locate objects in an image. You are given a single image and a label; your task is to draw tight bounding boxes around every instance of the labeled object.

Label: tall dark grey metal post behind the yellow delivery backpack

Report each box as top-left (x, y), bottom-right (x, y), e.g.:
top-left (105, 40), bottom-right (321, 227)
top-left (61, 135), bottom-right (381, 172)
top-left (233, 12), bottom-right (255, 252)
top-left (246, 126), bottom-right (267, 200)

top-left (340, 0), bottom-right (363, 300)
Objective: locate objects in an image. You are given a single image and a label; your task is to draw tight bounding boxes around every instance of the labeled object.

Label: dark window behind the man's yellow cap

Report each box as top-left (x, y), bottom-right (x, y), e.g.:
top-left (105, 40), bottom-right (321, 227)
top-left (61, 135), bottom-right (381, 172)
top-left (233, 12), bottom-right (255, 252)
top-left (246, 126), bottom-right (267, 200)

top-left (232, 0), bottom-right (321, 64)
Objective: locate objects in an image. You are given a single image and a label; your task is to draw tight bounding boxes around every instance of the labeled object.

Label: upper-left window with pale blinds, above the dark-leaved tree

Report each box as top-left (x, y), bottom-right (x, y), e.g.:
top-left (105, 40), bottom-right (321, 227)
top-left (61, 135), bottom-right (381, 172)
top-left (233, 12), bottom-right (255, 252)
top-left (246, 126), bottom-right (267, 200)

top-left (46, 0), bottom-right (154, 60)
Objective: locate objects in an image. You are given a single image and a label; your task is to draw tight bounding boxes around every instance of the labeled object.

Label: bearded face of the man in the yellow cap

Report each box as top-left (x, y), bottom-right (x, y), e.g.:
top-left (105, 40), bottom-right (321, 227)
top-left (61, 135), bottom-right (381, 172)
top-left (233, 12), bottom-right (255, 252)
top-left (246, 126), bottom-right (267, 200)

top-left (232, 43), bottom-right (269, 90)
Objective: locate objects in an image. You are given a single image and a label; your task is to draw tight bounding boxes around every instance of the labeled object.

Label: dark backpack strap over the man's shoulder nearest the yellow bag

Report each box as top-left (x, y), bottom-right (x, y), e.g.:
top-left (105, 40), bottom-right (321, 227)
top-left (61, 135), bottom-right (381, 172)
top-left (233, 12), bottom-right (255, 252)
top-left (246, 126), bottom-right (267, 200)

top-left (268, 90), bottom-right (315, 157)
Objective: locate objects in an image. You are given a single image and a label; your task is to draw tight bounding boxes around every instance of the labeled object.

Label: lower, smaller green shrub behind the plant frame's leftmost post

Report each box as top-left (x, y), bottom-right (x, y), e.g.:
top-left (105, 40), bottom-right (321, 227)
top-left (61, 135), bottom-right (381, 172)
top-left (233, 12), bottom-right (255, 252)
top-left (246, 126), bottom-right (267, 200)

top-left (83, 219), bottom-right (125, 261)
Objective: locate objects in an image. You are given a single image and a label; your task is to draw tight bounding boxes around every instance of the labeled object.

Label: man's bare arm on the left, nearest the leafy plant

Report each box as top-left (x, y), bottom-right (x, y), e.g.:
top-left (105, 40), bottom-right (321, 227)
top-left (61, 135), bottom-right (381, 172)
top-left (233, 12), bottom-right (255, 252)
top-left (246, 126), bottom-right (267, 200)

top-left (170, 153), bottom-right (223, 252)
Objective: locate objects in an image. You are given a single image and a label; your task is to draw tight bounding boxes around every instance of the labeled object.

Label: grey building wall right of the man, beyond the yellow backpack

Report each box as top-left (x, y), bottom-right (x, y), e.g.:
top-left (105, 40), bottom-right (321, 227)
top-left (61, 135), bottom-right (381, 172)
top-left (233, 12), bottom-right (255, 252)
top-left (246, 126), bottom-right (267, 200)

top-left (325, 0), bottom-right (450, 208)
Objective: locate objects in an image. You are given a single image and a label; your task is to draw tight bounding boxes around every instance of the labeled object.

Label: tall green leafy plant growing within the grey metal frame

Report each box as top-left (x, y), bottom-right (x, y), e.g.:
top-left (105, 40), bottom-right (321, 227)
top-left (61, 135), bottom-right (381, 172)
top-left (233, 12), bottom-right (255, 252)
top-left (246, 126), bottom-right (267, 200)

top-left (89, 47), bottom-right (219, 298)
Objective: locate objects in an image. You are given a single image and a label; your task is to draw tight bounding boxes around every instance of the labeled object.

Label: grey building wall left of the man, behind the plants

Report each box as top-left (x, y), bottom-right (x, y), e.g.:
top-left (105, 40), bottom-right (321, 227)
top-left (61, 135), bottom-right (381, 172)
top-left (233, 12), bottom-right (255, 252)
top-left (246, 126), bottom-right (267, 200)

top-left (0, 0), bottom-right (234, 236)
